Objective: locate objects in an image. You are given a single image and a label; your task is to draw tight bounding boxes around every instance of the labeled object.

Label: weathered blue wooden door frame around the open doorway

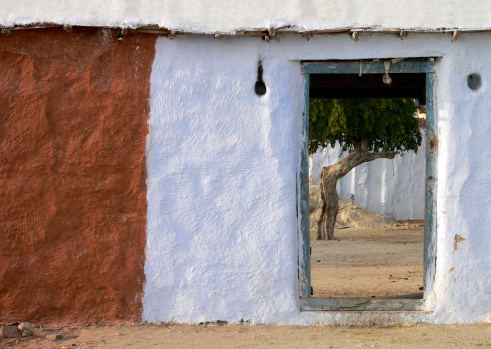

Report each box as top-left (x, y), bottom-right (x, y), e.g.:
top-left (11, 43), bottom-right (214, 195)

top-left (297, 59), bottom-right (437, 311)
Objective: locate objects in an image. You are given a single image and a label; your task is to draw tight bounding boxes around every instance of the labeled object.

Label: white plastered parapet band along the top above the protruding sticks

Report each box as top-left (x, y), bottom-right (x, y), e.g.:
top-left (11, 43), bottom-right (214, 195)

top-left (0, 0), bottom-right (491, 33)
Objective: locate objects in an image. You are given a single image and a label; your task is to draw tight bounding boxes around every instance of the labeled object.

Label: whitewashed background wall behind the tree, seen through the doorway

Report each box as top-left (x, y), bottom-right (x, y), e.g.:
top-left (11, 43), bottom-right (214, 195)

top-left (309, 137), bottom-right (426, 220)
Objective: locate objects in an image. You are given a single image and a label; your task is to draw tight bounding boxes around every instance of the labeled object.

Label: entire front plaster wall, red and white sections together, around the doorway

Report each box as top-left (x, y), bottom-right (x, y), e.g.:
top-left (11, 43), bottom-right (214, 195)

top-left (0, 28), bottom-right (491, 325)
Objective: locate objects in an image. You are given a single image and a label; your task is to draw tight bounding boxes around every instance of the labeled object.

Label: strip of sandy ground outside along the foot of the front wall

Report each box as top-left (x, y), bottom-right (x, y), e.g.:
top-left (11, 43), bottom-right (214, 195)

top-left (0, 323), bottom-right (491, 349)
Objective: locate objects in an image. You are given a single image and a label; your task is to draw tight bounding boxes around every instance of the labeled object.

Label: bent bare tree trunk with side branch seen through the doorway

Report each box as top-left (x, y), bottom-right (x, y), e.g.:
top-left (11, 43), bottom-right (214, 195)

top-left (317, 142), bottom-right (399, 240)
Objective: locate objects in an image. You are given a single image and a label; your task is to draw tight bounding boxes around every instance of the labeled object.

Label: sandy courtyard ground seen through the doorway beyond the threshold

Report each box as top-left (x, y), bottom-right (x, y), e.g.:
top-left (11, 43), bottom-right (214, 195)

top-left (310, 226), bottom-right (424, 298)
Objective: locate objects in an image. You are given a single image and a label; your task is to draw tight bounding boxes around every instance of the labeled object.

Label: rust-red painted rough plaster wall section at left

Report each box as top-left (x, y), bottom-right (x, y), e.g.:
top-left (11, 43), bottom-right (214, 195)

top-left (0, 28), bottom-right (156, 323)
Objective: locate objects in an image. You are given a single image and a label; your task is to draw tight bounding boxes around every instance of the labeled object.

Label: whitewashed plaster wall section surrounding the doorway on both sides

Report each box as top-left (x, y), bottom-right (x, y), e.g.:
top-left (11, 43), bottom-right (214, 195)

top-left (143, 34), bottom-right (491, 325)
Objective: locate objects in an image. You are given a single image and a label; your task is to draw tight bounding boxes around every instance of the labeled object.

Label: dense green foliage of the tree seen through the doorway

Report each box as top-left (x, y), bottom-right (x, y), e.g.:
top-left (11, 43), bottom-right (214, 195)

top-left (309, 98), bottom-right (422, 153)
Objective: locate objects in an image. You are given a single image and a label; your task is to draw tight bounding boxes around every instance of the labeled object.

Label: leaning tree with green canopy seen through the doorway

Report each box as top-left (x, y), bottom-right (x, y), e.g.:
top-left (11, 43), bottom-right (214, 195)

top-left (309, 99), bottom-right (422, 240)
